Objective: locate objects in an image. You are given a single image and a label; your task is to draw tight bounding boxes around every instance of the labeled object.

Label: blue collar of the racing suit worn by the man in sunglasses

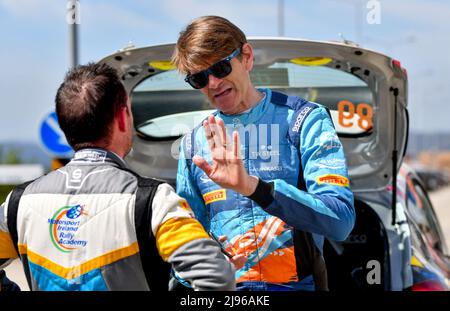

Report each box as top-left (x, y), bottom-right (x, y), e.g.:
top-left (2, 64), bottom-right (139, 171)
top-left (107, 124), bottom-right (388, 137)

top-left (217, 89), bottom-right (272, 126)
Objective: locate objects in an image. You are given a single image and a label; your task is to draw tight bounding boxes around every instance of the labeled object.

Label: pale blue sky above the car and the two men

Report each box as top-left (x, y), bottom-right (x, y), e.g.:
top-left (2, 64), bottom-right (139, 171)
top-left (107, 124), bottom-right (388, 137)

top-left (0, 0), bottom-right (450, 141)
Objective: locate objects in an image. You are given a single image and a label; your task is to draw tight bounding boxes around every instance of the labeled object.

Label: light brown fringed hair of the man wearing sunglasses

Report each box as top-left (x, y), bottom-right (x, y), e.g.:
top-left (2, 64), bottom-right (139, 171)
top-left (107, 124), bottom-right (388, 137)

top-left (172, 16), bottom-right (247, 74)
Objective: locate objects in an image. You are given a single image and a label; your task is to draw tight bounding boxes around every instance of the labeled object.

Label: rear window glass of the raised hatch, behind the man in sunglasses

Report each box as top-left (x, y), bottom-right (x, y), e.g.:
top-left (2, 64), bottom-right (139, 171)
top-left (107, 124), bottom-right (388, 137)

top-left (131, 57), bottom-right (375, 139)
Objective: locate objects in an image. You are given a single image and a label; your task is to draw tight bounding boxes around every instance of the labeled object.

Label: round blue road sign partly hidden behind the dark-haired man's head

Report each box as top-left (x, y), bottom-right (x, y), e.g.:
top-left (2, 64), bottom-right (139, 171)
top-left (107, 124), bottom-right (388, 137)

top-left (40, 111), bottom-right (72, 157)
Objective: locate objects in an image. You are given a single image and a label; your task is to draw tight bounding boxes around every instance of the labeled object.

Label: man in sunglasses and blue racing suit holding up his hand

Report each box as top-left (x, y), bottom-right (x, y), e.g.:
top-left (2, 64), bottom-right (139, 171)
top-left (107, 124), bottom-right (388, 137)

top-left (173, 16), bottom-right (355, 290)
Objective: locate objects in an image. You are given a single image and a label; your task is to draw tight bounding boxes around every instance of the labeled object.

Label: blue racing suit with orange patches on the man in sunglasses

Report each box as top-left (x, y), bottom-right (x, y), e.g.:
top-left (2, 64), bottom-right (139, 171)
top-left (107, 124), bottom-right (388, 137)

top-left (177, 89), bottom-right (355, 290)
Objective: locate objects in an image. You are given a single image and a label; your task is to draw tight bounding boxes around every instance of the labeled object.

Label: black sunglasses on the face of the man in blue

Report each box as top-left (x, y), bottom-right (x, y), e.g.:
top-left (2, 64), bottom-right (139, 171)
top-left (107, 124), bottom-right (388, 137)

top-left (184, 48), bottom-right (241, 89)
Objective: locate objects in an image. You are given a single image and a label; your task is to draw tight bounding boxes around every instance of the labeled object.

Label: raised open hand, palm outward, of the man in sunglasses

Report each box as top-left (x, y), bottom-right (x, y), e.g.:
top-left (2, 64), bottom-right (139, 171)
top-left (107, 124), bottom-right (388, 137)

top-left (192, 115), bottom-right (258, 196)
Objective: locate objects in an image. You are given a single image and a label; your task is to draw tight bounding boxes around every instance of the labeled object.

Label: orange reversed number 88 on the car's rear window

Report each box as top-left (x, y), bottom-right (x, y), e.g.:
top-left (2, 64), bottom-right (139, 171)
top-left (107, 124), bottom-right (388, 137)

top-left (338, 100), bottom-right (373, 132)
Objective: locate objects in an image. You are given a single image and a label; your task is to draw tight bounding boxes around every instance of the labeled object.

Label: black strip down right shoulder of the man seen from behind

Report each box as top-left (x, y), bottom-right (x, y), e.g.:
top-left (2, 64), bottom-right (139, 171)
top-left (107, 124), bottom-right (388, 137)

top-left (134, 176), bottom-right (170, 291)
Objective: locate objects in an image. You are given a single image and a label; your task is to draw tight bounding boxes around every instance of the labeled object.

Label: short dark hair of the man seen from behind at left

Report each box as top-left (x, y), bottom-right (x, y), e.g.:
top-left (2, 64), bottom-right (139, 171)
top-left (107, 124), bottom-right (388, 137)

top-left (56, 63), bottom-right (127, 150)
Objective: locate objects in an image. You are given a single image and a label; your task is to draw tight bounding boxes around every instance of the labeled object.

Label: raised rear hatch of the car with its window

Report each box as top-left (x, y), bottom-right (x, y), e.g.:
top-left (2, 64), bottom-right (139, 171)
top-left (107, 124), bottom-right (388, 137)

top-left (101, 38), bottom-right (408, 191)
